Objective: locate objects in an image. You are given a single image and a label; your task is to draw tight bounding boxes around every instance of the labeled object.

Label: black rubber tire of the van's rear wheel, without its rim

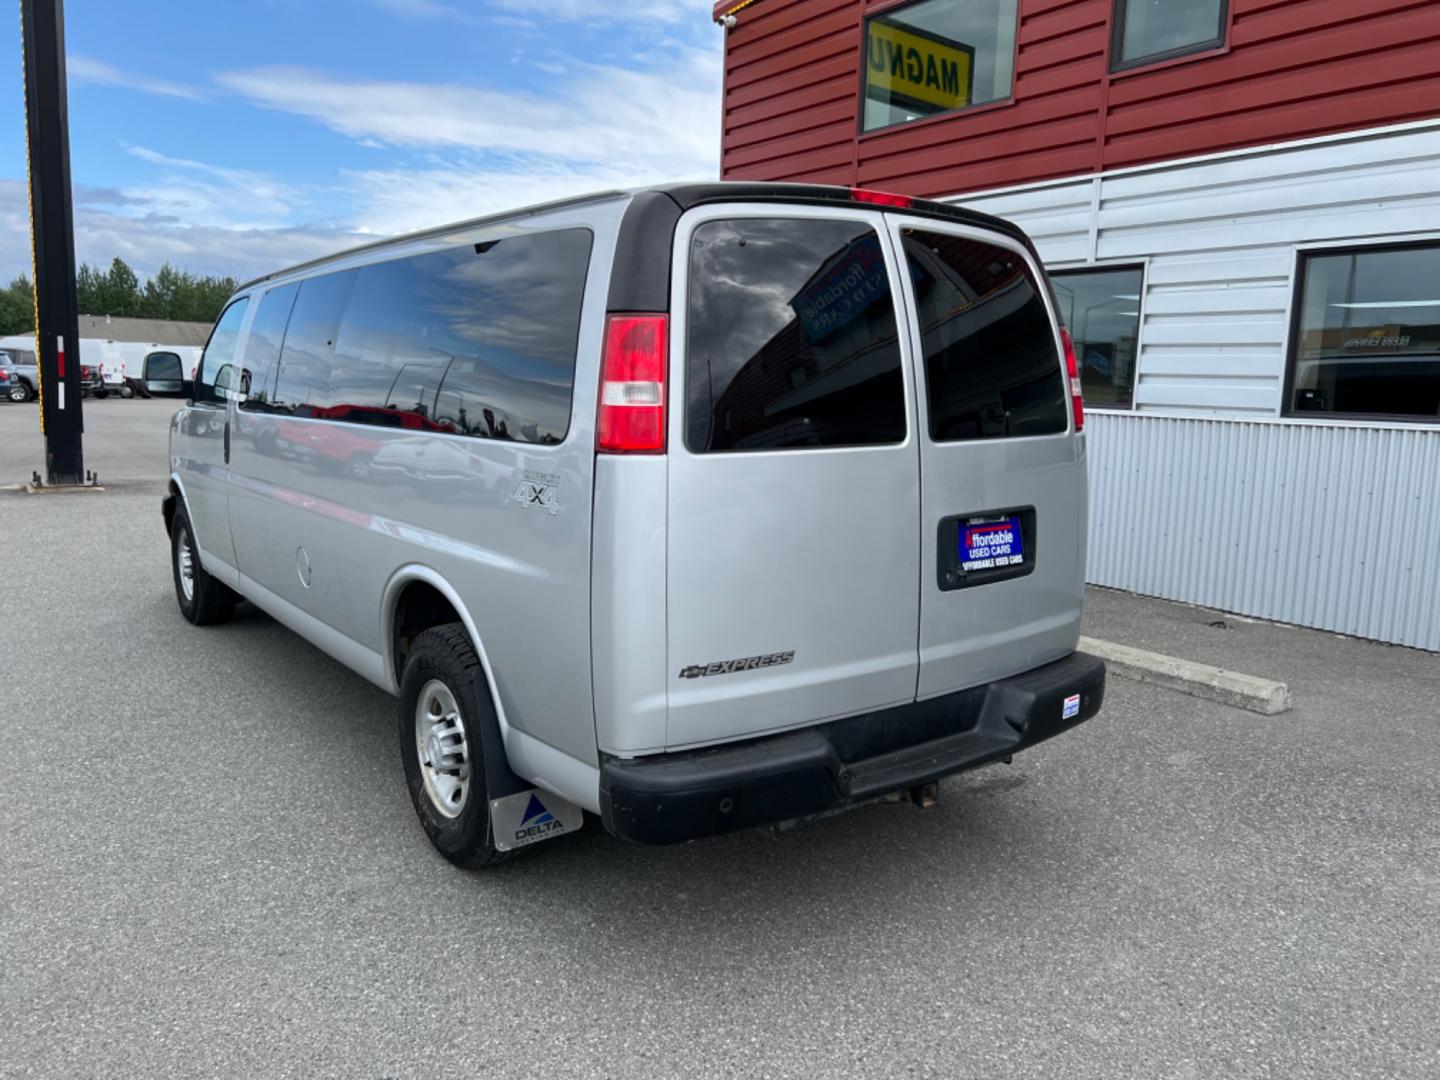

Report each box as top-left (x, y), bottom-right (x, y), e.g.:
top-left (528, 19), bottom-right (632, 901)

top-left (399, 622), bottom-right (513, 870)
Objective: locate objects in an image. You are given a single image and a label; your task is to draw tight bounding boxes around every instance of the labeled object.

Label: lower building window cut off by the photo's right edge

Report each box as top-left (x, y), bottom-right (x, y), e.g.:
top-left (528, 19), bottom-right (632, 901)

top-left (1287, 245), bottom-right (1440, 420)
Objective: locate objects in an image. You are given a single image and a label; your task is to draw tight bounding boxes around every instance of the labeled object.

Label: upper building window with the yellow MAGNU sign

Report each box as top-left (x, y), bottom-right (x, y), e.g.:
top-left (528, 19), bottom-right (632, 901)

top-left (861, 0), bottom-right (1018, 131)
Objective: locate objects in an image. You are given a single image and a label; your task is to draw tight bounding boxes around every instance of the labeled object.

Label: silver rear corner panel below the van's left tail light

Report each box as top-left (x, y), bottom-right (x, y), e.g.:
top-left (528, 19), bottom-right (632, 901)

top-left (590, 455), bottom-right (667, 756)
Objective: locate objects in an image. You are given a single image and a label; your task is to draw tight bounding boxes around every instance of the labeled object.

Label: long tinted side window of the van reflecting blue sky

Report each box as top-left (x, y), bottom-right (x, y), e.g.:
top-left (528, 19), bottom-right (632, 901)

top-left (264, 229), bottom-right (592, 444)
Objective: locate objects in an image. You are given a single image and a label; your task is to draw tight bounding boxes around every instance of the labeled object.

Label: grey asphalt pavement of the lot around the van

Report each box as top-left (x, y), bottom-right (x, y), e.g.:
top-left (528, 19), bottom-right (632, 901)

top-left (0, 399), bottom-right (1440, 1080)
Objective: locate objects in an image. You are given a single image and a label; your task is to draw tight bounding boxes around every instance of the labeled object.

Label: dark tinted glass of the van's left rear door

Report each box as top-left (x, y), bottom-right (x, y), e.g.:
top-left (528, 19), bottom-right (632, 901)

top-left (685, 217), bottom-right (906, 454)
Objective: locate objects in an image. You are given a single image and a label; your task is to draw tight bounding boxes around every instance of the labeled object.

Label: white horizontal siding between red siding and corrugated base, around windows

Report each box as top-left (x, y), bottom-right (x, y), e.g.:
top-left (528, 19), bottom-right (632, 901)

top-left (956, 124), bottom-right (1440, 416)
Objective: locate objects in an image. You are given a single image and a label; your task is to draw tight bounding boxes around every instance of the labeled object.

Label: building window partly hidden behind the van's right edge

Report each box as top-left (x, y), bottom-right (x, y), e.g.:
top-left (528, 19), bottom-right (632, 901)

top-left (1050, 266), bottom-right (1145, 409)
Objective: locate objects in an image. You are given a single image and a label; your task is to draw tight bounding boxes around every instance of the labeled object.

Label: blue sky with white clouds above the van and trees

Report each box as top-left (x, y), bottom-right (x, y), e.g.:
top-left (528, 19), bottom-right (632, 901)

top-left (0, 0), bottom-right (721, 281)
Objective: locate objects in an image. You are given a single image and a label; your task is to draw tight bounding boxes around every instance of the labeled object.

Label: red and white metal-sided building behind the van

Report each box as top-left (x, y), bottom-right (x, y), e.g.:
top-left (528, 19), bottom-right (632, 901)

top-left (714, 0), bottom-right (1440, 649)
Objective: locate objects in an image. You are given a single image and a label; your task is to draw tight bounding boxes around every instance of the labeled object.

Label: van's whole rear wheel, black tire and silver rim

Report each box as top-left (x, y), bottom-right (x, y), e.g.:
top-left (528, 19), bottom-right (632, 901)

top-left (399, 622), bottom-right (508, 870)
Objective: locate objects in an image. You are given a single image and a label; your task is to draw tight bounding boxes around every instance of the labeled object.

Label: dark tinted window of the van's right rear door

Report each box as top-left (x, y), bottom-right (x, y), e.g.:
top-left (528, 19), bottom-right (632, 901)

top-left (903, 229), bottom-right (1070, 442)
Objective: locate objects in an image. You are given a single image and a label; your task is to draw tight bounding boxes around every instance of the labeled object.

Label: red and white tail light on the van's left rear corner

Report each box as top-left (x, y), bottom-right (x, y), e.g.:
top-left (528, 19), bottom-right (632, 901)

top-left (595, 315), bottom-right (668, 454)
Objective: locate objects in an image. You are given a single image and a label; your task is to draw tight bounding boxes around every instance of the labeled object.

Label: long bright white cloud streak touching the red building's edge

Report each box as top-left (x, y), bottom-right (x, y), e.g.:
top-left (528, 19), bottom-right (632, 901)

top-left (216, 46), bottom-right (720, 176)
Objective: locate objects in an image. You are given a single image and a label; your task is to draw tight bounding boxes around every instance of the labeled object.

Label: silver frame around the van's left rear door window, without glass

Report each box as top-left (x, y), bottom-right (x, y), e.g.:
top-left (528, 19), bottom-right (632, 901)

top-left (665, 203), bottom-right (920, 461)
